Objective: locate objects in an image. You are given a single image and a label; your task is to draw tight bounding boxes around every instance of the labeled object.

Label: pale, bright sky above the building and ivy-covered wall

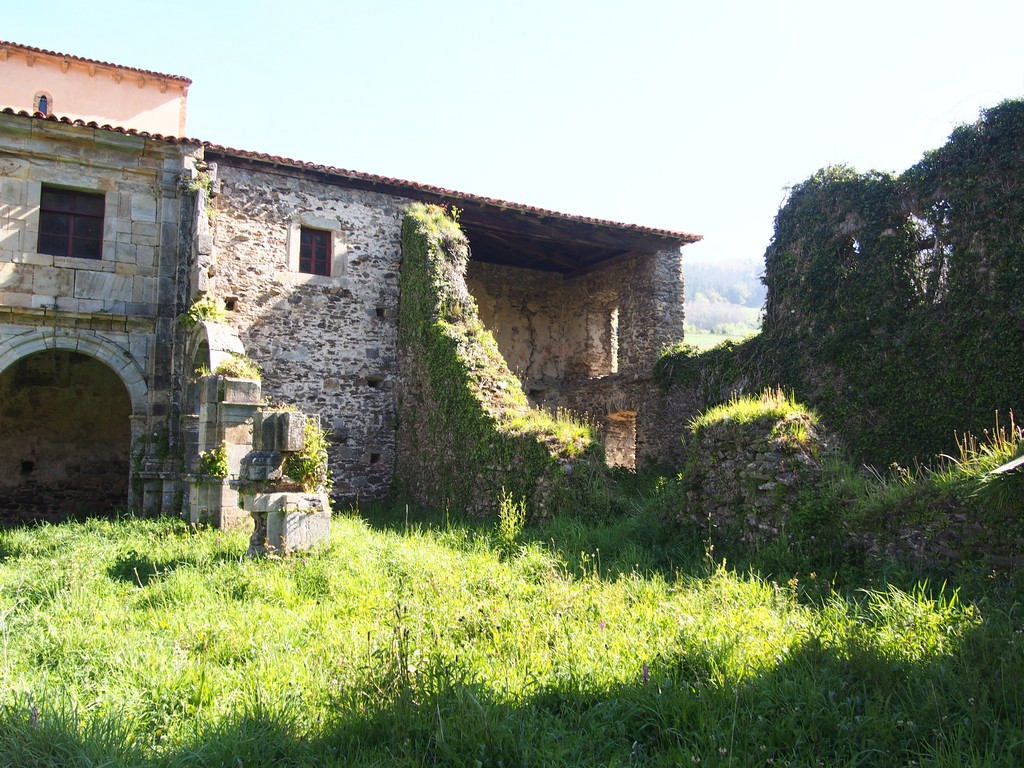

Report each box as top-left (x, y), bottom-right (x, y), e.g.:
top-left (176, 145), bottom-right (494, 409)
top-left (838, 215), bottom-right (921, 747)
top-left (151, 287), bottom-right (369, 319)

top-left (0, 0), bottom-right (1024, 261)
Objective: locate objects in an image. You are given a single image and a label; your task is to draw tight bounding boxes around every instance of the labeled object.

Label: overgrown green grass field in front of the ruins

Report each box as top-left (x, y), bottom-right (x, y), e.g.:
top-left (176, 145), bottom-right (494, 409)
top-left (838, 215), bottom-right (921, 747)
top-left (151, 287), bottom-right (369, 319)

top-left (0, 509), bottom-right (1024, 768)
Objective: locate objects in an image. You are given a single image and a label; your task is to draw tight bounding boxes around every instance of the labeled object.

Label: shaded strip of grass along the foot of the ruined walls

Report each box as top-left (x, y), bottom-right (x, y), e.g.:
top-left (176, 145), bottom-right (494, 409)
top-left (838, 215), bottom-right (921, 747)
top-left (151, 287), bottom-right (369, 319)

top-left (352, 493), bottom-right (1024, 602)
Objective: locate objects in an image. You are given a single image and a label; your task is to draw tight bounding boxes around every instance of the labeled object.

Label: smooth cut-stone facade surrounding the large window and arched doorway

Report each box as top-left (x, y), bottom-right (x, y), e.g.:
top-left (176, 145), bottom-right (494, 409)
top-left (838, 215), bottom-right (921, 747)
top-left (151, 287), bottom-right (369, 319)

top-left (0, 114), bottom-right (196, 520)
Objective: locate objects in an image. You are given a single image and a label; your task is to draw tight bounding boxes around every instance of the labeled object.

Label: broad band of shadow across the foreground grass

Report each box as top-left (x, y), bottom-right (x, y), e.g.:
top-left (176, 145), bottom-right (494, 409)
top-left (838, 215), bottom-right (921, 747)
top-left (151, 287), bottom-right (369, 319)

top-left (0, 614), bottom-right (1024, 768)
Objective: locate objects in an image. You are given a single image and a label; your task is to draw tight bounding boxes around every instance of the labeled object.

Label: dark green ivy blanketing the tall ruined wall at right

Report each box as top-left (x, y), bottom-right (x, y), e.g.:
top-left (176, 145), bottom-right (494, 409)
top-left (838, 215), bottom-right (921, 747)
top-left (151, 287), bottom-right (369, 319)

top-left (658, 100), bottom-right (1024, 465)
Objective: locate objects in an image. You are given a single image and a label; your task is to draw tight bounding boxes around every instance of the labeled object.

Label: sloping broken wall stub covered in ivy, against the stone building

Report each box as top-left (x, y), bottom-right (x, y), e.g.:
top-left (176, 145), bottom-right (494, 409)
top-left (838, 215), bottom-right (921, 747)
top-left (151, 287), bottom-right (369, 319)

top-left (395, 204), bottom-right (604, 515)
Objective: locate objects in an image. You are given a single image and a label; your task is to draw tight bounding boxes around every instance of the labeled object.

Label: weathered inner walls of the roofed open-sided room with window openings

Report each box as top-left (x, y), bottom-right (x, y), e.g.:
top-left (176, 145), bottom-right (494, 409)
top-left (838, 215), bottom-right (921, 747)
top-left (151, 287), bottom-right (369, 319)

top-left (466, 249), bottom-right (683, 468)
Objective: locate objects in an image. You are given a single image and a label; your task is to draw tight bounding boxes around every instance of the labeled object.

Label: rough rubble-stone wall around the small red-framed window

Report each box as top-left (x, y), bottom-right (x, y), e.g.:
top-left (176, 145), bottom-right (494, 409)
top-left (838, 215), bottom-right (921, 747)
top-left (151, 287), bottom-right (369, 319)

top-left (208, 159), bottom-right (408, 500)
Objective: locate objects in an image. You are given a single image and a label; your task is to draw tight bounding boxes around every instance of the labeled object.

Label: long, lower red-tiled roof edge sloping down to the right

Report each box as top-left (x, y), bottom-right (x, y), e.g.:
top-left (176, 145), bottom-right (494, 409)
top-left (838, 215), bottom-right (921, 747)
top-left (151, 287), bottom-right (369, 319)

top-left (0, 108), bottom-right (703, 243)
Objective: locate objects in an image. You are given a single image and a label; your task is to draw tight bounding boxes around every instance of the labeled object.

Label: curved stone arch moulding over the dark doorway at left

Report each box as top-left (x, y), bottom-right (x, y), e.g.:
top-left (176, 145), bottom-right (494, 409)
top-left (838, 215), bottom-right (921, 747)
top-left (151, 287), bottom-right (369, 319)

top-left (0, 328), bottom-right (150, 416)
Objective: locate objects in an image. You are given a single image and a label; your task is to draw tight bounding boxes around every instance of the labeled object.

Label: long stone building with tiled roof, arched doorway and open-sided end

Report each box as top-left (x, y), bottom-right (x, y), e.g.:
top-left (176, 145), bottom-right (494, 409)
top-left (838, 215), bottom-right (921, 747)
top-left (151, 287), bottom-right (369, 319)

top-left (0, 43), bottom-right (698, 518)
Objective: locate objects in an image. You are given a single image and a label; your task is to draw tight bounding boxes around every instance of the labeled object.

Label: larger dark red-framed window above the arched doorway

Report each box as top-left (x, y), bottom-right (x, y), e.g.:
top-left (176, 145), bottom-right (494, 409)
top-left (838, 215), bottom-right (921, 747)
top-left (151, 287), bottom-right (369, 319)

top-left (38, 186), bottom-right (103, 259)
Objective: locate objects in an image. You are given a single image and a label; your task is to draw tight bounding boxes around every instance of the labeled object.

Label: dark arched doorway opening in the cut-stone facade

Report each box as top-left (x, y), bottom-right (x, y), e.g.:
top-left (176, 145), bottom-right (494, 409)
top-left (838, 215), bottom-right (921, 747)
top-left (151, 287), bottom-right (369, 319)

top-left (0, 348), bottom-right (132, 524)
